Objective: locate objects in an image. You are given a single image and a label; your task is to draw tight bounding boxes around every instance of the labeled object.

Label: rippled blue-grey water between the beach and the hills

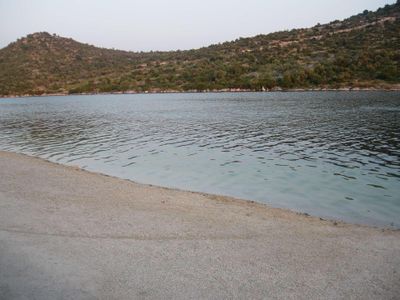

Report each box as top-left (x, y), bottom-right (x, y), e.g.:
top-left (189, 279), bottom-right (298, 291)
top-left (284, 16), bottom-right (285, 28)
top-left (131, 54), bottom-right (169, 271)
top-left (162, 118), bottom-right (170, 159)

top-left (0, 92), bottom-right (400, 228)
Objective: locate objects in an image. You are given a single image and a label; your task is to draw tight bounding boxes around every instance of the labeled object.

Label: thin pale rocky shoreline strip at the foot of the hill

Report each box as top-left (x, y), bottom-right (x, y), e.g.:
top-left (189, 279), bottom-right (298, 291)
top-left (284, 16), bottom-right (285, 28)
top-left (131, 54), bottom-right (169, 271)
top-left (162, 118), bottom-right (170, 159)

top-left (0, 85), bottom-right (400, 98)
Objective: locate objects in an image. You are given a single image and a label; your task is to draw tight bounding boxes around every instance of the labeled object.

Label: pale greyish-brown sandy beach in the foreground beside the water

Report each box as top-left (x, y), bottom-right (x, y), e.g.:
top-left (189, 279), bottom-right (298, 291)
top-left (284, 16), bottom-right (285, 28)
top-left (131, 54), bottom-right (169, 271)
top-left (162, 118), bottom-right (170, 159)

top-left (0, 152), bottom-right (400, 299)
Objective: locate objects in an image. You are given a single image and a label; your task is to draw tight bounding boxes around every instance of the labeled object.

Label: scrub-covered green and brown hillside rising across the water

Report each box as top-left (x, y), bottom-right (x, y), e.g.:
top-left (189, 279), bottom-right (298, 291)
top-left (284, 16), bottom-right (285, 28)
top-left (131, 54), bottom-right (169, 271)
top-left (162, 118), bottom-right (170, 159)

top-left (0, 2), bottom-right (400, 96)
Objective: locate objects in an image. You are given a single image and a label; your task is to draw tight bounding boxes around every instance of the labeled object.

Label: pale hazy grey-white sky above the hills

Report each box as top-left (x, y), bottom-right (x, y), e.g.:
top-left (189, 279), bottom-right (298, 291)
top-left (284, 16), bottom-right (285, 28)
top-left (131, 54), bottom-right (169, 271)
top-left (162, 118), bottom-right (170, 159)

top-left (0, 0), bottom-right (395, 51)
